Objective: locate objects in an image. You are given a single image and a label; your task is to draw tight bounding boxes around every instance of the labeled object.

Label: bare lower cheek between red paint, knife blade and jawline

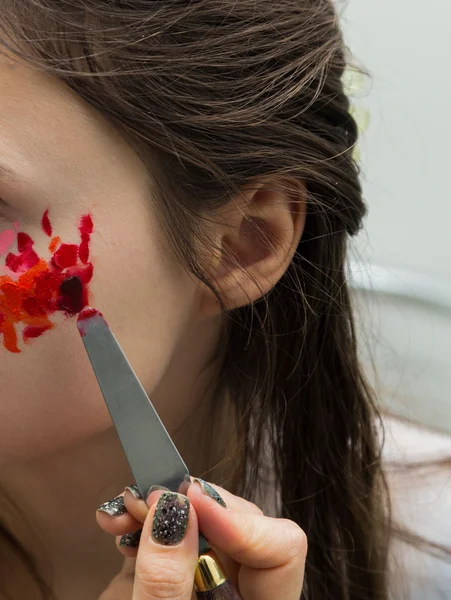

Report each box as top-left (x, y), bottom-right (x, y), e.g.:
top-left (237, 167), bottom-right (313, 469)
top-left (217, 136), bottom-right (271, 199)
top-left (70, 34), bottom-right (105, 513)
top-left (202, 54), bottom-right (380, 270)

top-left (0, 322), bottom-right (109, 468)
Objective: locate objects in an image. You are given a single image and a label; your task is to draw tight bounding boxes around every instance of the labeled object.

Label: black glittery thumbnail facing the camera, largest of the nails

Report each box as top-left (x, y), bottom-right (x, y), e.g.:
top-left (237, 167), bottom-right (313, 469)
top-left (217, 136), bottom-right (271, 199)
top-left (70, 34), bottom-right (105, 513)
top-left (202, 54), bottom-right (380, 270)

top-left (152, 492), bottom-right (190, 546)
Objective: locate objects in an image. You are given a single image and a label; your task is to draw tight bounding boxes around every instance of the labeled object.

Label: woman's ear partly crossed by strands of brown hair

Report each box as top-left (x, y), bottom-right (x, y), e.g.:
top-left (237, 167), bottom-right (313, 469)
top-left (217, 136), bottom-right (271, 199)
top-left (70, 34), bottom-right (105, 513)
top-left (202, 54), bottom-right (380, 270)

top-left (202, 180), bottom-right (307, 316)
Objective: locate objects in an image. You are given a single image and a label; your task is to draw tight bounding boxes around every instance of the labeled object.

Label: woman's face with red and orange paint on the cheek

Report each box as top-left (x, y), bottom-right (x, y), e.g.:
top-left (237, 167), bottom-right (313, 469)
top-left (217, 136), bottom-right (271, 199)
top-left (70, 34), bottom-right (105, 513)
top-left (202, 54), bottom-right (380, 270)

top-left (0, 56), bottom-right (205, 466)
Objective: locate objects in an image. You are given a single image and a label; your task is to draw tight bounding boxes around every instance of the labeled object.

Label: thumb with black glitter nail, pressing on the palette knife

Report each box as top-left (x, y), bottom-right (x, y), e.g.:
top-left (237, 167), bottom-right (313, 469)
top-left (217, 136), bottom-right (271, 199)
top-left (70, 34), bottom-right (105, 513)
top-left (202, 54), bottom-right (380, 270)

top-left (133, 492), bottom-right (199, 600)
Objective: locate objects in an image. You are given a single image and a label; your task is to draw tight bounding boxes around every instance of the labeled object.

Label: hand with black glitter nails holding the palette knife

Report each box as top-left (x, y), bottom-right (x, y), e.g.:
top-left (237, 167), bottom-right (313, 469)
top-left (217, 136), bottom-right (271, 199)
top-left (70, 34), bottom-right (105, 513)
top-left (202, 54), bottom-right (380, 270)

top-left (97, 479), bottom-right (307, 600)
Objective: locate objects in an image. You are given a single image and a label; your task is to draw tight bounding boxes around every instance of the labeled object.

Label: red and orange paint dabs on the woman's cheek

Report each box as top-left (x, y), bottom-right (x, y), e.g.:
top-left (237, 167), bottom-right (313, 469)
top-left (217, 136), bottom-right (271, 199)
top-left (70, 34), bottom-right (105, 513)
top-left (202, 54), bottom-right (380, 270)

top-left (0, 210), bottom-right (94, 352)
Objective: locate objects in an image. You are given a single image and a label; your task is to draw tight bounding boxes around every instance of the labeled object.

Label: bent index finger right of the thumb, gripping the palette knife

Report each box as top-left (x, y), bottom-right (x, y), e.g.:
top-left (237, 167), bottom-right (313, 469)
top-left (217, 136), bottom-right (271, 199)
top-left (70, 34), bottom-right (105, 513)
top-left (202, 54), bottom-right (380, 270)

top-left (190, 485), bottom-right (307, 600)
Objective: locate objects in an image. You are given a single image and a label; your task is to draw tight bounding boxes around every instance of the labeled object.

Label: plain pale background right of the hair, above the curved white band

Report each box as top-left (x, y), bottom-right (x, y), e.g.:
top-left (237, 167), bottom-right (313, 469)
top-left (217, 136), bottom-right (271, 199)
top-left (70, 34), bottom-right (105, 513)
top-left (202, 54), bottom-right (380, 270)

top-left (338, 0), bottom-right (451, 282)
